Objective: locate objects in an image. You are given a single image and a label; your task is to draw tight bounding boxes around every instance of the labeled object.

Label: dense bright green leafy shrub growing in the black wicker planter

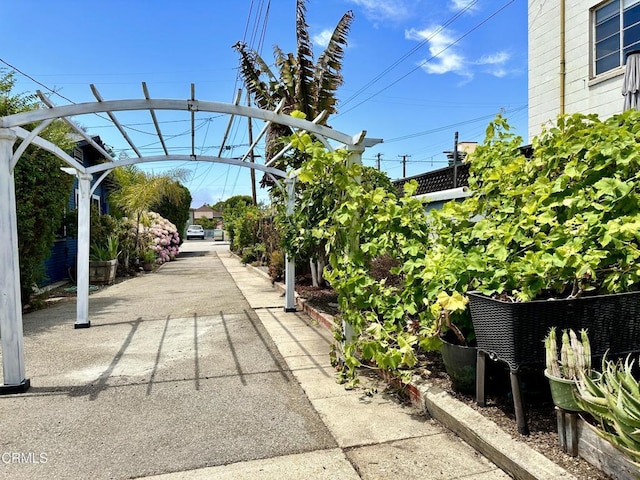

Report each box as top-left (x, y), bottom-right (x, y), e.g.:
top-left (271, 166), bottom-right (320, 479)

top-left (442, 110), bottom-right (640, 301)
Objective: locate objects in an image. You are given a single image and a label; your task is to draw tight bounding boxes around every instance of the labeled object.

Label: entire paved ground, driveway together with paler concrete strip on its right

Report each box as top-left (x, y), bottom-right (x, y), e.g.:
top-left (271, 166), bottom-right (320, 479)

top-left (0, 241), bottom-right (509, 479)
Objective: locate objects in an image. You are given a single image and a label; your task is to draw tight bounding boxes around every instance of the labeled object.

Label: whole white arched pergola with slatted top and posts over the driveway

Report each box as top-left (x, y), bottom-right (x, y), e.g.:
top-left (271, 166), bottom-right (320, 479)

top-left (0, 83), bottom-right (381, 394)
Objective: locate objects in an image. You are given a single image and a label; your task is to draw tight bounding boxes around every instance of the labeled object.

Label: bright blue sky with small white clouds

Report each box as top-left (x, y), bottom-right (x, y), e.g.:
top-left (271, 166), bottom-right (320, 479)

top-left (0, 0), bottom-right (528, 206)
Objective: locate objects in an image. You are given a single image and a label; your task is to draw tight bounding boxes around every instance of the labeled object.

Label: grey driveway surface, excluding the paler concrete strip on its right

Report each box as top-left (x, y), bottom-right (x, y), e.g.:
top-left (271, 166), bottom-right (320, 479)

top-left (0, 241), bottom-right (336, 479)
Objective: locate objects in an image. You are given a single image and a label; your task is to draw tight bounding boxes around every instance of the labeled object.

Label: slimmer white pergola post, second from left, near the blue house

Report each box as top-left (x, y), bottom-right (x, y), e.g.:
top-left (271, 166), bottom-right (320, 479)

top-left (73, 172), bottom-right (93, 328)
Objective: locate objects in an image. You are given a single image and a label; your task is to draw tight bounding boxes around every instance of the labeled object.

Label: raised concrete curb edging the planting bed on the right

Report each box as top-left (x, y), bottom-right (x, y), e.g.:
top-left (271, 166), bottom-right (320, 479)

top-left (239, 258), bottom-right (576, 480)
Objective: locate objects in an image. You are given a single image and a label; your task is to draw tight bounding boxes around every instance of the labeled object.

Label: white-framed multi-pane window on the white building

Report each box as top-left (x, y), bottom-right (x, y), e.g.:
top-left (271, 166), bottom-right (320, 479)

top-left (592, 0), bottom-right (640, 75)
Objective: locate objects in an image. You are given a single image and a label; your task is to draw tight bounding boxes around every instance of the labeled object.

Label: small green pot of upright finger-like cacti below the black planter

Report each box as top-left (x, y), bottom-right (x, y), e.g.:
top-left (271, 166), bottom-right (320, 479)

top-left (544, 327), bottom-right (592, 412)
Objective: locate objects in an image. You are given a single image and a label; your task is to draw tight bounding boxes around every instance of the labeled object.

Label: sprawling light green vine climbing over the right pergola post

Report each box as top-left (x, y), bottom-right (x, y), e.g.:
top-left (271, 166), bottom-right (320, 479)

top-left (284, 135), bottom-right (466, 378)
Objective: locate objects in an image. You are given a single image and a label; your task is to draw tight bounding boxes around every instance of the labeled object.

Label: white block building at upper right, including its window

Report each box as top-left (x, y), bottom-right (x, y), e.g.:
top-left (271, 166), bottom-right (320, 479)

top-left (528, 0), bottom-right (640, 140)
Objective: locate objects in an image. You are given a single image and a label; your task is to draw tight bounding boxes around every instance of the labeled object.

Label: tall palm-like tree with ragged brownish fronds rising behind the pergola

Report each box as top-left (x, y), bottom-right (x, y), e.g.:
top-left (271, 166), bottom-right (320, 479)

top-left (234, 0), bottom-right (353, 167)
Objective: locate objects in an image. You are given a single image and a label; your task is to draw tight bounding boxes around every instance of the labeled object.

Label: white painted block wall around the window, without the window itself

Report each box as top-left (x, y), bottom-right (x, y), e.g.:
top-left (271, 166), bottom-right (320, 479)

top-left (528, 0), bottom-right (624, 141)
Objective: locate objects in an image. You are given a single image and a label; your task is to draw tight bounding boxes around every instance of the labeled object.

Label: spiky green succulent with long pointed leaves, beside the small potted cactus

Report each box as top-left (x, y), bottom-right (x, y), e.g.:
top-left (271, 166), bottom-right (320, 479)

top-left (576, 355), bottom-right (640, 467)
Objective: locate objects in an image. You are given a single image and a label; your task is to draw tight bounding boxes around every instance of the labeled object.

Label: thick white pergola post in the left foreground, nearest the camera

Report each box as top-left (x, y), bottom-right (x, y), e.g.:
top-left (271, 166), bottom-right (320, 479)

top-left (0, 128), bottom-right (30, 394)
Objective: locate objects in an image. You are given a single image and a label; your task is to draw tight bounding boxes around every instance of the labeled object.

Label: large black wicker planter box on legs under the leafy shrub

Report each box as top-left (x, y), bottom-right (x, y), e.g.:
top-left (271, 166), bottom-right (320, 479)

top-left (468, 292), bottom-right (640, 433)
